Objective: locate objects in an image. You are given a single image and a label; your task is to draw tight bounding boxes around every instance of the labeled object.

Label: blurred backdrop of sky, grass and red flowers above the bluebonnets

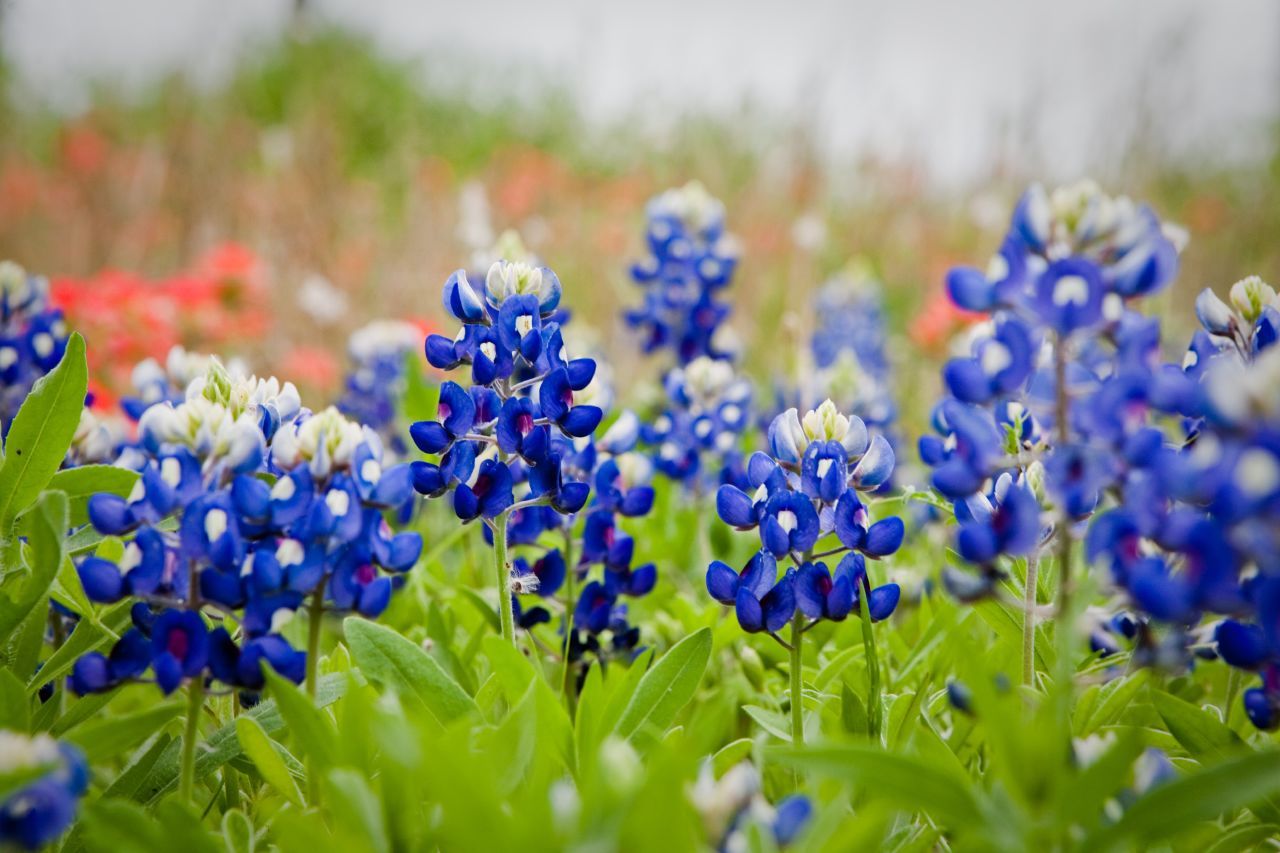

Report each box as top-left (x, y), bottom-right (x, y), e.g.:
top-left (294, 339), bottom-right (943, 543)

top-left (0, 0), bottom-right (1280, 417)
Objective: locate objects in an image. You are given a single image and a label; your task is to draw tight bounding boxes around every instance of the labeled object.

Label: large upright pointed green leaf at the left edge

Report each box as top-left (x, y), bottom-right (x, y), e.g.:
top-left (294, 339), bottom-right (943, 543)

top-left (0, 334), bottom-right (88, 527)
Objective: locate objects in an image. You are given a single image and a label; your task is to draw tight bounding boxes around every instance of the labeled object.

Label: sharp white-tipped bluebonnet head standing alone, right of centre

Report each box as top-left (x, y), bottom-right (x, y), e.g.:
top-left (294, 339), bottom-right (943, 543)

top-left (707, 400), bottom-right (904, 634)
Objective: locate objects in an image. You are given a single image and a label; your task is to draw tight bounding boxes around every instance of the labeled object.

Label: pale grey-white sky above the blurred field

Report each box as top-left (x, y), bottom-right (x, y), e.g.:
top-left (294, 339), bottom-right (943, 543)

top-left (0, 0), bottom-right (1280, 183)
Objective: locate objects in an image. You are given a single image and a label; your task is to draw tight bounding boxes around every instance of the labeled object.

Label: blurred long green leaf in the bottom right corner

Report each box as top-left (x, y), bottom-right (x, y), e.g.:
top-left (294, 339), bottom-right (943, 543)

top-left (1082, 751), bottom-right (1280, 850)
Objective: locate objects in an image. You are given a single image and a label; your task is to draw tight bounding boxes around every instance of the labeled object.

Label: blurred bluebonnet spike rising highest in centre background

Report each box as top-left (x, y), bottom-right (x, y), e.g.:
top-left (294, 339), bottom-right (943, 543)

top-left (625, 182), bottom-right (739, 364)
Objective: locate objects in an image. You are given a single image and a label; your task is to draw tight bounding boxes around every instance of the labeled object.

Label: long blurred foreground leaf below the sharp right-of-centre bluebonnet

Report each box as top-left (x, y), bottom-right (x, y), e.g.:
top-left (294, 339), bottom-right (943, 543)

top-left (768, 744), bottom-right (982, 829)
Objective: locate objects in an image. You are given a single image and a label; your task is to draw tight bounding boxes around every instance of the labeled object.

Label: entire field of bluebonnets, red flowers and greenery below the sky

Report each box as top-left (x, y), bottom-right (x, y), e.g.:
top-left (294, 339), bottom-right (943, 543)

top-left (0, 26), bottom-right (1280, 853)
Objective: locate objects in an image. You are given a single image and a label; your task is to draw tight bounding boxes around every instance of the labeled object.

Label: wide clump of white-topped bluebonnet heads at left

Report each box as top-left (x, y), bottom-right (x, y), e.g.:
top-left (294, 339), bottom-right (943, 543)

top-left (72, 361), bottom-right (421, 693)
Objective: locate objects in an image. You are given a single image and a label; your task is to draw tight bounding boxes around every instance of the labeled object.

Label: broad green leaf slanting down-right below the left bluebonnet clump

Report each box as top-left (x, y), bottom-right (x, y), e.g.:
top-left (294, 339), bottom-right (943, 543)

top-left (343, 616), bottom-right (480, 724)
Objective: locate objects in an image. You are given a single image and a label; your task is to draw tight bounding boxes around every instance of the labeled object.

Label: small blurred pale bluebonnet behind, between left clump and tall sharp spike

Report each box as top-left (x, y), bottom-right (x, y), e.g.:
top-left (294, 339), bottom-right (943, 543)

top-left (338, 320), bottom-right (422, 456)
